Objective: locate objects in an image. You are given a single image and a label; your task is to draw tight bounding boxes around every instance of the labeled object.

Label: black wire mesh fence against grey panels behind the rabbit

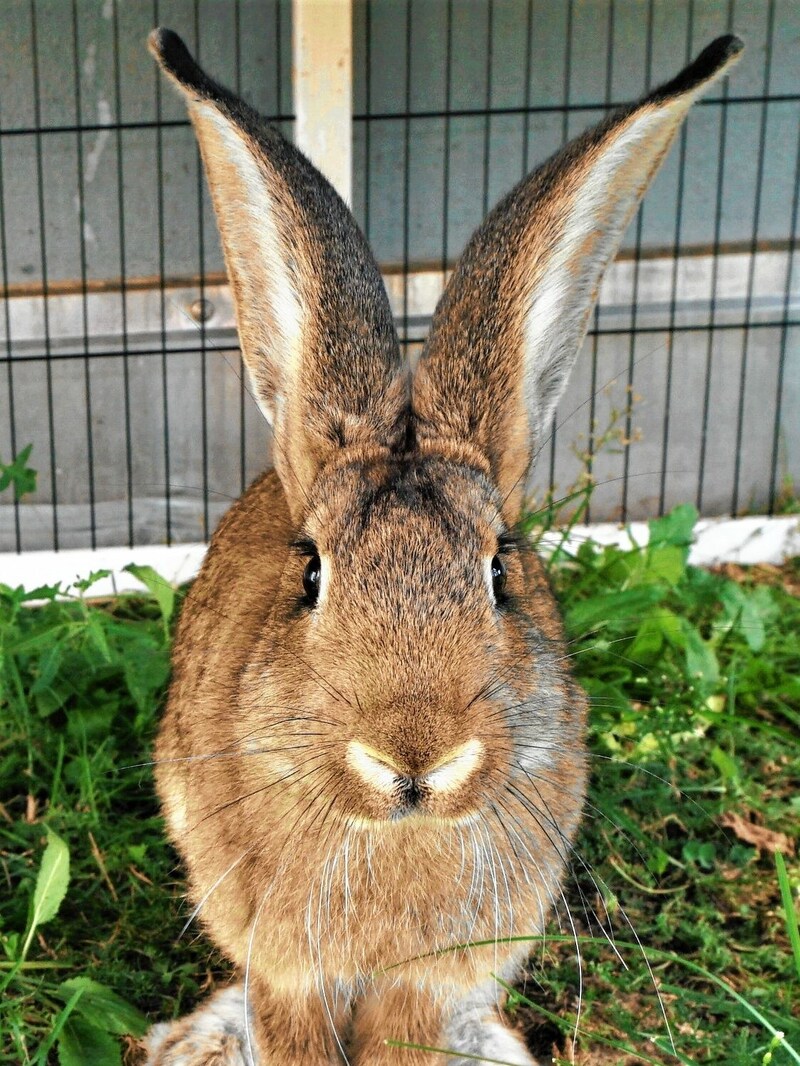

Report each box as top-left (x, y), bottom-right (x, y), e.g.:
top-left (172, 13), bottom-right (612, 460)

top-left (0, 0), bottom-right (800, 551)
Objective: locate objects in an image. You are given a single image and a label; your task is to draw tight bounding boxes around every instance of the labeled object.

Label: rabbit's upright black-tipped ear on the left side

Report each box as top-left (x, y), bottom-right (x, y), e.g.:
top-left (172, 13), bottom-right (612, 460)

top-left (148, 29), bottom-right (409, 520)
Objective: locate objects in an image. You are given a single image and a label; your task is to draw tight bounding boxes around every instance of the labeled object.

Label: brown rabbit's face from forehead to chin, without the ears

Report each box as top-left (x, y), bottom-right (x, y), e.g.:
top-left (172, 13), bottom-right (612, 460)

top-left (241, 456), bottom-right (583, 828)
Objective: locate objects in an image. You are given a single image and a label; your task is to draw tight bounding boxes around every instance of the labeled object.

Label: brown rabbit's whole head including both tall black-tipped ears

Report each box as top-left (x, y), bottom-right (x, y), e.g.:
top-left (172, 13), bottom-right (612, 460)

top-left (150, 30), bottom-right (741, 854)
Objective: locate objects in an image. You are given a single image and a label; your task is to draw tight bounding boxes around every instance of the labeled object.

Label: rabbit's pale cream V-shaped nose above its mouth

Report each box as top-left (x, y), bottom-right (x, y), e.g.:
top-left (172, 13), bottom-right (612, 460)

top-left (346, 739), bottom-right (483, 802)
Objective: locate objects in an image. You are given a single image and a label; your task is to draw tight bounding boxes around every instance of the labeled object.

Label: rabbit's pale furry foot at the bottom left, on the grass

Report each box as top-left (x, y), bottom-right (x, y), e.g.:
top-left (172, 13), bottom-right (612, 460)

top-left (145, 985), bottom-right (259, 1066)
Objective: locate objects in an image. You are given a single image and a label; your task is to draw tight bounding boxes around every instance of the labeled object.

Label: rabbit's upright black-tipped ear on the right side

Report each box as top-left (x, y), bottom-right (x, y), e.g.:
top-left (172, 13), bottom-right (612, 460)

top-left (412, 36), bottom-right (743, 521)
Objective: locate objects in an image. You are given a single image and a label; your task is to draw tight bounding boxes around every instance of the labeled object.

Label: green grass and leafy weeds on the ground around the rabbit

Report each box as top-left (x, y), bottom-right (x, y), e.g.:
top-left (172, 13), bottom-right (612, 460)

top-left (0, 486), bottom-right (800, 1066)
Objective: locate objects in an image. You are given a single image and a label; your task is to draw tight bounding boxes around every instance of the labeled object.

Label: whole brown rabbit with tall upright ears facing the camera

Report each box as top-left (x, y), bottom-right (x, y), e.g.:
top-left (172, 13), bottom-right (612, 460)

top-left (148, 30), bottom-right (742, 1066)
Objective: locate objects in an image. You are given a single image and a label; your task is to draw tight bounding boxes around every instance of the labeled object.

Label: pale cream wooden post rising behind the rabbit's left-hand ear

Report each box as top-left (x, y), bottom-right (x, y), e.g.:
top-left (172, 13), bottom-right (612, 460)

top-left (292, 0), bottom-right (353, 205)
